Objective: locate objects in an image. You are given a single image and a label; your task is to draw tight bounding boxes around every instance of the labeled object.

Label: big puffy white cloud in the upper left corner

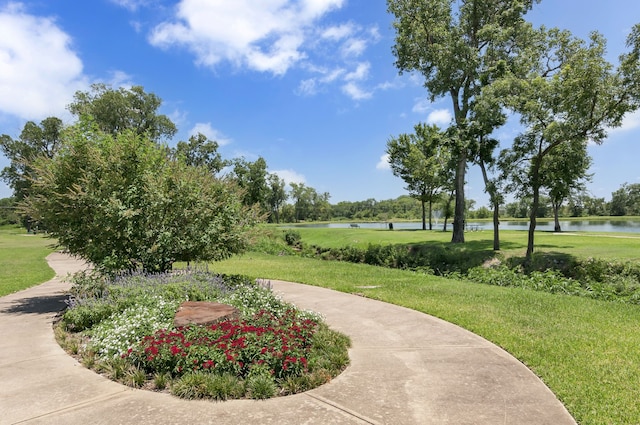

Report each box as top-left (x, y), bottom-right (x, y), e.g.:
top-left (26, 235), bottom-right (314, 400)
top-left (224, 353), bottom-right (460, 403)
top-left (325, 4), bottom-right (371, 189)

top-left (0, 3), bottom-right (89, 120)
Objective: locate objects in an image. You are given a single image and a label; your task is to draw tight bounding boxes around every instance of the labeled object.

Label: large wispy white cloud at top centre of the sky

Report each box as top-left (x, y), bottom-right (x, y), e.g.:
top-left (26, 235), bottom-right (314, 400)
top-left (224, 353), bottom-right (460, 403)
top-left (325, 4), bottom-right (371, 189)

top-left (150, 0), bottom-right (344, 75)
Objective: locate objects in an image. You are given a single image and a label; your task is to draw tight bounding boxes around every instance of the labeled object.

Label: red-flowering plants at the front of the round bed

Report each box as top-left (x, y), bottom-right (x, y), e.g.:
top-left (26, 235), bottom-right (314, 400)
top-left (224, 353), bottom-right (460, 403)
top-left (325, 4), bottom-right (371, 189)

top-left (123, 309), bottom-right (318, 379)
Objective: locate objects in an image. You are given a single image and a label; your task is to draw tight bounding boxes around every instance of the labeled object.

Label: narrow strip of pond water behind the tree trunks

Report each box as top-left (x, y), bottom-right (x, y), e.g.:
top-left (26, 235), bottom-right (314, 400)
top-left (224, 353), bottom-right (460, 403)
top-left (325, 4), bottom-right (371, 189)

top-left (282, 220), bottom-right (640, 233)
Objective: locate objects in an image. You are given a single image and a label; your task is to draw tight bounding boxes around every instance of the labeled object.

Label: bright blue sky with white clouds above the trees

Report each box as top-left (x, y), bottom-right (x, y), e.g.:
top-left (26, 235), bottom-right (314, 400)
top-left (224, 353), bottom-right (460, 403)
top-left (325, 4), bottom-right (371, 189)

top-left (0, 0), bottom-right (640, 205)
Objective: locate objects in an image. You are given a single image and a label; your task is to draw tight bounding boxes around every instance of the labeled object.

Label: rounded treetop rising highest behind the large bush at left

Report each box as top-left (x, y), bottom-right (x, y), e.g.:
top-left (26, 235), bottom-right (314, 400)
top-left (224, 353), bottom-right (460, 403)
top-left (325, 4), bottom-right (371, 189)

top-left (68, 84), bottom-right (177, 141)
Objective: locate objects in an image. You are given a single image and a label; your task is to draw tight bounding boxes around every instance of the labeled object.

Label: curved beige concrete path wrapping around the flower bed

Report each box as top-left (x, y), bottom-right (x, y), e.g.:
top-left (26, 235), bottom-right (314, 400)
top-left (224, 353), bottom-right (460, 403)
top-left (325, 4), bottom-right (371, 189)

top-left (0, 253), bottom-right (575, 425)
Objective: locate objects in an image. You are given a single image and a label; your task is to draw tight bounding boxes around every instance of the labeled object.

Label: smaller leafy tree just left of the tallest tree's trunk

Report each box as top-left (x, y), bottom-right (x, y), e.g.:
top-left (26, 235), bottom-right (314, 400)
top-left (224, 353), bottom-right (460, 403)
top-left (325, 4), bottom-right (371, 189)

top-left (387, 124), bottom-right (453, 230)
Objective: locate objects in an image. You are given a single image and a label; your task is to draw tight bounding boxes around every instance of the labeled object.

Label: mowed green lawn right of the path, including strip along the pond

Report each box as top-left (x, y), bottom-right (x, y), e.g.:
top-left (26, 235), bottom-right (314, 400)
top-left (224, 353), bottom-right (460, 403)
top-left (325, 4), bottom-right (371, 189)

top-left (212, 229), bottom-right (640, 424)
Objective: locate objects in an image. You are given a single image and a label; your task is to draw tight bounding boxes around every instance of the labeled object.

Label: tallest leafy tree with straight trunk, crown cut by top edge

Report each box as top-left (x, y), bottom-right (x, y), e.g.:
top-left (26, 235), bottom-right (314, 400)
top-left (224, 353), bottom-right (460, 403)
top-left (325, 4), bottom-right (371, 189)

top-left (387, 0), bottom-right (536, 242)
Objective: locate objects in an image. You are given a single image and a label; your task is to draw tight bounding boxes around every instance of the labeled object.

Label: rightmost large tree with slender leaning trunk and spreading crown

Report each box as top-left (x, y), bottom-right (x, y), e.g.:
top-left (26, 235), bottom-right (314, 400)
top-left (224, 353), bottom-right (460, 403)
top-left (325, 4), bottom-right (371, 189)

top-left (492, 25), bottom-right (640, 259)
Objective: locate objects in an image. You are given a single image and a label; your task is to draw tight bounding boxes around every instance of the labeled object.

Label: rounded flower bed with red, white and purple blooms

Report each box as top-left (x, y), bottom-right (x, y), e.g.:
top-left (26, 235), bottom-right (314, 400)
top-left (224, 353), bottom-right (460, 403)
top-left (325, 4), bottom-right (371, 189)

top-left (56, 273), bottom-right (349, 400)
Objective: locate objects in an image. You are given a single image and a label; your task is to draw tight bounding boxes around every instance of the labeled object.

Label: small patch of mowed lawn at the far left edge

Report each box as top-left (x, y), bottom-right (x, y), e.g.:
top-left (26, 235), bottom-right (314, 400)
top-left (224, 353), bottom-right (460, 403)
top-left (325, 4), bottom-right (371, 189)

top-left (0, 226), bottom-right (55, 296)
